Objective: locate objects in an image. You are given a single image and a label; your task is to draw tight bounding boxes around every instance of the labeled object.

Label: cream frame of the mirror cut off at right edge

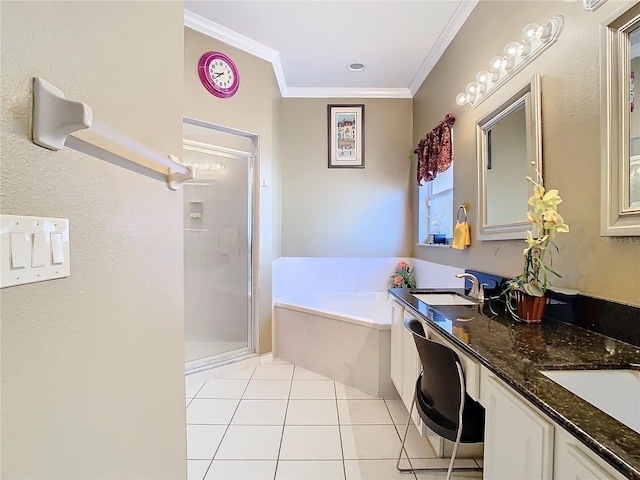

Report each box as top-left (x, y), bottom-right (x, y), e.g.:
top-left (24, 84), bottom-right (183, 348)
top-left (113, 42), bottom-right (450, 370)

top-left (600, 2), bottom-right (640, 237)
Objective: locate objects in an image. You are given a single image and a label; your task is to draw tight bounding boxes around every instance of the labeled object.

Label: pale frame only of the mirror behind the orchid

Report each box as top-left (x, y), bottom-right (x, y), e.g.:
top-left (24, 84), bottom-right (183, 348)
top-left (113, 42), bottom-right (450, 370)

top-left (476, 73), bottom-right (542, 240)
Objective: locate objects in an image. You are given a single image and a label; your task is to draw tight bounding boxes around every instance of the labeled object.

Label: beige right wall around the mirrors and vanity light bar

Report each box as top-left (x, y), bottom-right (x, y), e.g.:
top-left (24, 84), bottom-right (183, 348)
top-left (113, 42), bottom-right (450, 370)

top-left (413, 0), bottom-right (640, 305)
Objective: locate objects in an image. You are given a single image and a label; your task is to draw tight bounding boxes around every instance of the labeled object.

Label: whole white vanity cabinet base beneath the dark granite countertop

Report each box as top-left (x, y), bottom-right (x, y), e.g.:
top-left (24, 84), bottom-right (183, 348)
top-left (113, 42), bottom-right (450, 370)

top-left (391, 294), bottom-right (626, 480)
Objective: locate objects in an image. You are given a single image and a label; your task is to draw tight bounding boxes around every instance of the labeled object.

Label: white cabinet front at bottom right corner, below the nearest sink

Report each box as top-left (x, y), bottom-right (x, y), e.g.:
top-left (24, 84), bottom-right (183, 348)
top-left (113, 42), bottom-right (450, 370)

top-left (553, 428), bottom-right (625, 480)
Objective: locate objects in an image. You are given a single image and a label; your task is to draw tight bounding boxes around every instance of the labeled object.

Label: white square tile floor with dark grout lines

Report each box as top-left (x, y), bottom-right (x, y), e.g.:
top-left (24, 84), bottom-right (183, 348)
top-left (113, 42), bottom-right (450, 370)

top-left (186, 361), bottom-right (482, 480)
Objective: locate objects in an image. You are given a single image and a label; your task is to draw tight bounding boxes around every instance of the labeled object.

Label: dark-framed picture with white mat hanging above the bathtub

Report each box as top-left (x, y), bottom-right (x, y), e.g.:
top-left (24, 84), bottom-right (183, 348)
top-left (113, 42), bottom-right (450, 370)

top-left (327, 105), bottom-right (364, 168)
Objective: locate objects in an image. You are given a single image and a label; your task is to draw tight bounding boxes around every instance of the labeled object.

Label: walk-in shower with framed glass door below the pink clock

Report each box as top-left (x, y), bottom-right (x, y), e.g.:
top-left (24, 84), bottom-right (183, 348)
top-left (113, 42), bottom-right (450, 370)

top-left (183, 119), bottom-right (255, 371)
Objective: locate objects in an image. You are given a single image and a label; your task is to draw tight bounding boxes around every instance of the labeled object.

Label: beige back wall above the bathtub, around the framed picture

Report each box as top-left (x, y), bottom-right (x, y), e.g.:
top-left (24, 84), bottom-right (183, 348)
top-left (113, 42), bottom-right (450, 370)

top-left (279, 99), bottom-right (415, 257)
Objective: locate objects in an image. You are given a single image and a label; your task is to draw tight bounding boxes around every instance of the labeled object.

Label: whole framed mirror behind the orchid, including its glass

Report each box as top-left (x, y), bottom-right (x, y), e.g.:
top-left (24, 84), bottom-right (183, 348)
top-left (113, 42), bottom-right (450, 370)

top-left (476, 75), bottom-right (542, 240)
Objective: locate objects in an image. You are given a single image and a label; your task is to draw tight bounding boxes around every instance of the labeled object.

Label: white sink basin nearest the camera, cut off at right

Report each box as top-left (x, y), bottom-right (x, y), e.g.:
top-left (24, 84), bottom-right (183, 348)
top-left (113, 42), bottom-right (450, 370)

top-left (540, 370), bottom-right (640, 433)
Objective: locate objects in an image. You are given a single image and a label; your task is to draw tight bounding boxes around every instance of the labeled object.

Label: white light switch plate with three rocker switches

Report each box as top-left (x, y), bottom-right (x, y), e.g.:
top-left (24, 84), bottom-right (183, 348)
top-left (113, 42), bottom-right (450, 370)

top-left (0, 215), bottom-right (71, 288)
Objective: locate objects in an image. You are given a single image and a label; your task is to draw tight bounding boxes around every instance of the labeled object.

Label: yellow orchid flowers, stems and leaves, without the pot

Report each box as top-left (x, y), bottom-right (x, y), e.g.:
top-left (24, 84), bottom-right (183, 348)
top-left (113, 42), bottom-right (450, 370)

top-left (507, 163), bottom-right (569, 305)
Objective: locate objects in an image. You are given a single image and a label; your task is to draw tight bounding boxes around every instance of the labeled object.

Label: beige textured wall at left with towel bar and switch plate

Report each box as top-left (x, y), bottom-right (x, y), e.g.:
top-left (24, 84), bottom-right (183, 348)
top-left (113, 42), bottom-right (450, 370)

top-left (0, 2), bottom-right (186, 479)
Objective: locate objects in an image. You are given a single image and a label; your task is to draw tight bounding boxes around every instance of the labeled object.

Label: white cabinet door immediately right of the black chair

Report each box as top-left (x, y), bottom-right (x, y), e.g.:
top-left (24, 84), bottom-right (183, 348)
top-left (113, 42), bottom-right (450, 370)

top-left (480, 369), bottom-right (553, 480)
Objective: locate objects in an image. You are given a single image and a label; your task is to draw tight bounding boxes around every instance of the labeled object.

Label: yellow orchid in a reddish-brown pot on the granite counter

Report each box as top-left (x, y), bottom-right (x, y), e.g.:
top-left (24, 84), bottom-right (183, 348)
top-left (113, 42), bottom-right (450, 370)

top-left (506, 164), bottom-right (569, 323)
